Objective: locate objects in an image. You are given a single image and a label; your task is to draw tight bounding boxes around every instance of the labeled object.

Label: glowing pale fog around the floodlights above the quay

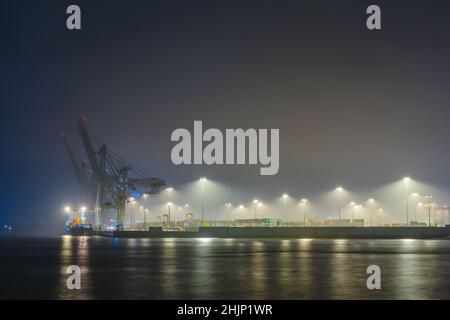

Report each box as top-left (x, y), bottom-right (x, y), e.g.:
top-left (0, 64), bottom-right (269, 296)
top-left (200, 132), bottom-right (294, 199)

top-left (61, 178), bottom-right (449, 227)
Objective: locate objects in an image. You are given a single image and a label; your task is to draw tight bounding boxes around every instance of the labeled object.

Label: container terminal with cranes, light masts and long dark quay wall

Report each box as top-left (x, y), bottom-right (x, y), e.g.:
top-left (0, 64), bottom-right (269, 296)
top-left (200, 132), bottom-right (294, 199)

top-left (62, 117), bottom-right (450, 239)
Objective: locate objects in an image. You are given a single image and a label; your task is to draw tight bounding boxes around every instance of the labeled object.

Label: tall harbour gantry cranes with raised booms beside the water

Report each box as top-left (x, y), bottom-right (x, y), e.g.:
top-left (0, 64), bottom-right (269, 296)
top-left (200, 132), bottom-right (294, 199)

top-left (63, 117), bottom-right (165, 229)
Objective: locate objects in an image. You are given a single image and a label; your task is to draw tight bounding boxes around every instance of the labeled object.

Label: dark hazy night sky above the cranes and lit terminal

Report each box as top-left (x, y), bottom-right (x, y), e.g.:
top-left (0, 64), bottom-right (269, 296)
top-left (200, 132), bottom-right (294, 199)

top-left (0, 0), bottom-right (450, 225)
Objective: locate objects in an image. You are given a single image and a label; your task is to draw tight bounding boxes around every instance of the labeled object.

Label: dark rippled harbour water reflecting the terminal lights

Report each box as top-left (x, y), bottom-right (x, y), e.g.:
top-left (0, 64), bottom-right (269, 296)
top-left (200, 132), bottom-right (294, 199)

top-left (0, 236), bottom-right (450, 299)
